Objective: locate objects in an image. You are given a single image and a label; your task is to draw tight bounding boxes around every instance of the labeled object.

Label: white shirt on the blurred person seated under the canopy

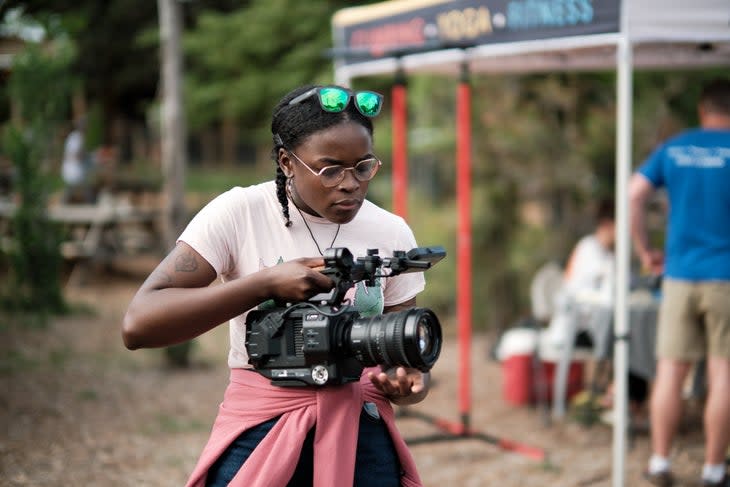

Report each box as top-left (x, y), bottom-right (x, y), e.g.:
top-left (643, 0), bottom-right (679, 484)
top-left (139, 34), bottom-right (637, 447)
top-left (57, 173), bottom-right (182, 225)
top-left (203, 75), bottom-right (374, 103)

top-left (563, 234), bottom-right (615, 305)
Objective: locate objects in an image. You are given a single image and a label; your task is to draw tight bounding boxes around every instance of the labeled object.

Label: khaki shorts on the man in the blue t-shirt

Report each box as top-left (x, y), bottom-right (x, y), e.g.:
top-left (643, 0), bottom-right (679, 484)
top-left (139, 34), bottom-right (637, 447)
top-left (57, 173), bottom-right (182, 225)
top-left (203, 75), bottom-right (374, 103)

top-left (656, 279), bottom-right (730, 361)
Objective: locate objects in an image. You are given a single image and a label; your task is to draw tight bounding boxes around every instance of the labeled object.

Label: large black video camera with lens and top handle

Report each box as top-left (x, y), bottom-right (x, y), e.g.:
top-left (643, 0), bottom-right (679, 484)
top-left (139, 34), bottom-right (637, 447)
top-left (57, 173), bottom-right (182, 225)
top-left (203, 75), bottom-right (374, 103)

top-left (246, 247), bottom-right (446, 386)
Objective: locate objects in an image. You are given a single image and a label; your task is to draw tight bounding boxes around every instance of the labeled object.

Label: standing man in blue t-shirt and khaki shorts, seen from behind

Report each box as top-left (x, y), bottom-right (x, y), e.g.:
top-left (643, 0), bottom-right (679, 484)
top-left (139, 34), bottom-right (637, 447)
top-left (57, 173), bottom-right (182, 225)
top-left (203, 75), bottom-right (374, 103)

top-left (629, 79), bottom-right (730, 486)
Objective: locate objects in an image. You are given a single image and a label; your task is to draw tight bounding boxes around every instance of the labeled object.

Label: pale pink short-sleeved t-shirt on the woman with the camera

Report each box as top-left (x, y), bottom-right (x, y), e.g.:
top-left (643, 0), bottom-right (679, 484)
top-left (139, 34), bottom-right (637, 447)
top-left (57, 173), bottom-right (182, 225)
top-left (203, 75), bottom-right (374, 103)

top-left (179, 181), bottom-right (425, 368)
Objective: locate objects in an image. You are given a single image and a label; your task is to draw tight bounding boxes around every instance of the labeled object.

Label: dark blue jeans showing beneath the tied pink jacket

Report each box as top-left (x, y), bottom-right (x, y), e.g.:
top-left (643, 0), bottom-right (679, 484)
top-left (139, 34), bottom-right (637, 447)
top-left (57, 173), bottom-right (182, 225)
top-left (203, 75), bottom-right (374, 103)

top-left (205, 410), bottom-right (402, 487)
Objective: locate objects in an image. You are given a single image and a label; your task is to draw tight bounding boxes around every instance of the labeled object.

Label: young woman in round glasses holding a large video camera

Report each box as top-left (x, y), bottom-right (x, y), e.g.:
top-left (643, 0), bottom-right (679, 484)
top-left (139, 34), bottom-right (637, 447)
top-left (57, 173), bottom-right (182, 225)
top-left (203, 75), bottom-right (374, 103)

top-left (122, 86), bottom-right (428, 487)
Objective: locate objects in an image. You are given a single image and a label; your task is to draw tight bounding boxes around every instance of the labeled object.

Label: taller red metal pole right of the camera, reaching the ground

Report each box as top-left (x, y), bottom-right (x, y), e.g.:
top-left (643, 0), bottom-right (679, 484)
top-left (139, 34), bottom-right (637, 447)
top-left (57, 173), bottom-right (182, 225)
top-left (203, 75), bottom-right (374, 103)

top-left (456, 65), bottom-right (472, 427)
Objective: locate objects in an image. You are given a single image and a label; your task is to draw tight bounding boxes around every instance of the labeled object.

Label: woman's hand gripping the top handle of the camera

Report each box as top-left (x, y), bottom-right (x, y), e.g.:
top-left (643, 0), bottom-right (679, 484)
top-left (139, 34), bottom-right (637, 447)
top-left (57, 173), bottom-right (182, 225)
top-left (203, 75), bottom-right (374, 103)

top-left (260, 257), bottom-right (334, 303)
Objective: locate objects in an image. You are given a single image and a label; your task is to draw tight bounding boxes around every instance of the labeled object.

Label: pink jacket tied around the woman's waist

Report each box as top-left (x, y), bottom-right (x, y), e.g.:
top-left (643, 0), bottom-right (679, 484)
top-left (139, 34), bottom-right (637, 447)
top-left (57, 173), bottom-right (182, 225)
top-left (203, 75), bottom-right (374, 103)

top-left (187, 369), bottom-right (422, 487)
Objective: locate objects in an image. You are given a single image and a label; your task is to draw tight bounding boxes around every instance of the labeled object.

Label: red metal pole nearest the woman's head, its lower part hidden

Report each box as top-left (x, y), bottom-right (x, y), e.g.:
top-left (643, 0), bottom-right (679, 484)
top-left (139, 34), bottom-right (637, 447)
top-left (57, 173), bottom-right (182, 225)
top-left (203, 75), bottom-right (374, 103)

top-left (391, 74), bottom-right (408, 219)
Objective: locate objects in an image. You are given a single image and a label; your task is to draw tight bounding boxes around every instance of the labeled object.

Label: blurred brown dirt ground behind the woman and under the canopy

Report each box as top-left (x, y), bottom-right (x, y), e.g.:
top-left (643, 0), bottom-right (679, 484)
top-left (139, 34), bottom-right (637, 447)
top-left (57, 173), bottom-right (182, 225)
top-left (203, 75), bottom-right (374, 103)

top-left (0, 261), bottom-right (702, 487)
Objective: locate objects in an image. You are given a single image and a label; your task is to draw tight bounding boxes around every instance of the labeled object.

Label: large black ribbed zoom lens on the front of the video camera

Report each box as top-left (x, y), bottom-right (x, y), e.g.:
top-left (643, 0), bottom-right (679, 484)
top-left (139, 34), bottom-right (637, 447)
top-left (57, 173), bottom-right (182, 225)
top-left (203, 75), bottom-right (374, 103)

top-left (346, 308), bottom-right (441, 372)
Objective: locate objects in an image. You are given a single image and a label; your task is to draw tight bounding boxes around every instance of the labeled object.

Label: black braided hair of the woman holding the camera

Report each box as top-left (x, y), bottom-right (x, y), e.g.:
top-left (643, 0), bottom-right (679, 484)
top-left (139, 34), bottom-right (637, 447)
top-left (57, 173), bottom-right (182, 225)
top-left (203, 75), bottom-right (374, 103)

top-left (271, 85), bottom-right (373, 227)
